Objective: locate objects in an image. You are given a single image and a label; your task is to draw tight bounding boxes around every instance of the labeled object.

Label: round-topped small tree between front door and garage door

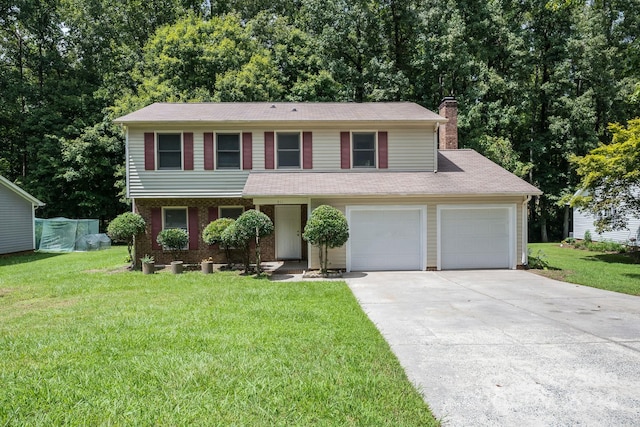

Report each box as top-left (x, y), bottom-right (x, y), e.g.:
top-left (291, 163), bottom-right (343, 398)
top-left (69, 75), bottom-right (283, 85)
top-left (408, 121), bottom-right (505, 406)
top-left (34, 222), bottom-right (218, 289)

top-left (302, 205), bottom-right (349, 274)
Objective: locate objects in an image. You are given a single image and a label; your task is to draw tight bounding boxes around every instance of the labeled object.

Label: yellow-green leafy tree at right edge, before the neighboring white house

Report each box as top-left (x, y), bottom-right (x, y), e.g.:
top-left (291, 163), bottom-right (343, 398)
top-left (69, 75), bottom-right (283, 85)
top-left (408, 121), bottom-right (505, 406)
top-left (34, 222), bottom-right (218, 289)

top-left (572, 118), bottom-right (640, 232)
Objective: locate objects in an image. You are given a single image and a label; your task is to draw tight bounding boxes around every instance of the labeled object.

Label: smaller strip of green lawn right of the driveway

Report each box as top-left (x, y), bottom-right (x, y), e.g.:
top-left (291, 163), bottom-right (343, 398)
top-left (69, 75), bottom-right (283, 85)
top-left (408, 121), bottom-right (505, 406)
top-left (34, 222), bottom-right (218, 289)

top-left (529, 243), bottom-right (640, 295)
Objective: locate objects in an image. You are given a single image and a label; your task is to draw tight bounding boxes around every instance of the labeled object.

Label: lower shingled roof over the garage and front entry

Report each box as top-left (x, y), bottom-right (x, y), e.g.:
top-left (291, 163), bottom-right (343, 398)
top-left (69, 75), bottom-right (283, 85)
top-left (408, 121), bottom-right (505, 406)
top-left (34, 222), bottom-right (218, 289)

top-left (242, 150), bottom-right (542, 197)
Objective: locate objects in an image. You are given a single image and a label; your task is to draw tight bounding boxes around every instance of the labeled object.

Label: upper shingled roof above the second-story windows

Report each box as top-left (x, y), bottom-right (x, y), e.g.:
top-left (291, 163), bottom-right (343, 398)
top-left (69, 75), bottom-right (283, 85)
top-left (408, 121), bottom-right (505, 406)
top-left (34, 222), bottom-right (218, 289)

top-left (114, 102), bottom-right (447, 124)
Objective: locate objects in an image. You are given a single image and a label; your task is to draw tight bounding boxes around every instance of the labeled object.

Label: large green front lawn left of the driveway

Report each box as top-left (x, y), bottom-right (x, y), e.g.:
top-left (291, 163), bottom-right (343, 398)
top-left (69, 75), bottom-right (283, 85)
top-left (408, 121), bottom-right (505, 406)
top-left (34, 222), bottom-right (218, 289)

top-left (0, 247), bottom-right (437, 426)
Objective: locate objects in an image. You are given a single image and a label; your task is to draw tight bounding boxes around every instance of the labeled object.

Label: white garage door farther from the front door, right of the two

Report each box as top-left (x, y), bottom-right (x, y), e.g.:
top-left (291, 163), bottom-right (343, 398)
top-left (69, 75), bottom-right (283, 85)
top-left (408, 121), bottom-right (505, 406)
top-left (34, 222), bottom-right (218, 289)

top-left (438, 207), bottom-right (515, 270)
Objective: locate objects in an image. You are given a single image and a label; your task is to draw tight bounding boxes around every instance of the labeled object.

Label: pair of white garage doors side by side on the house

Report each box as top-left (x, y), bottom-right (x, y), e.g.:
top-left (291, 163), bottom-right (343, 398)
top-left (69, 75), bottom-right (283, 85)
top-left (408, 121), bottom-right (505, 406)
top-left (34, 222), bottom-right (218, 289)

top-left (347, 206), bottom-right (514, 271)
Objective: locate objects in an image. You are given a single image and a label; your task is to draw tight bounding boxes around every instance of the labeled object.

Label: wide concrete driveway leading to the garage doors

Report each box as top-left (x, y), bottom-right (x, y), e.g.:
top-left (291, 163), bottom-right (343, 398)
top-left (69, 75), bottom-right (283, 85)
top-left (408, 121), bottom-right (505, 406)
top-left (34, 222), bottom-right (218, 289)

top-left (346, 271), bottom-right (640, 426)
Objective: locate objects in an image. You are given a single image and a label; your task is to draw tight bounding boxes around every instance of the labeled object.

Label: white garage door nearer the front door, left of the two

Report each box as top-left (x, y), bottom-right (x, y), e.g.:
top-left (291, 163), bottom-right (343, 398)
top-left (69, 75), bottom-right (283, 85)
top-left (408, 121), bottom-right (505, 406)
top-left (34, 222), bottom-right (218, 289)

top-left (347, 206), bottom-right (426, 271)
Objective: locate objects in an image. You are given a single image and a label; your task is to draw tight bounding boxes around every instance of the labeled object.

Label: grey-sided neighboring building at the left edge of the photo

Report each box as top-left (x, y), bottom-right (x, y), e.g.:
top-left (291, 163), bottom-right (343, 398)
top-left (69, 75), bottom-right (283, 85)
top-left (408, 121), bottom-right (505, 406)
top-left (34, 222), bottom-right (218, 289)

top-left (0, 176), bottom-right (44, 254)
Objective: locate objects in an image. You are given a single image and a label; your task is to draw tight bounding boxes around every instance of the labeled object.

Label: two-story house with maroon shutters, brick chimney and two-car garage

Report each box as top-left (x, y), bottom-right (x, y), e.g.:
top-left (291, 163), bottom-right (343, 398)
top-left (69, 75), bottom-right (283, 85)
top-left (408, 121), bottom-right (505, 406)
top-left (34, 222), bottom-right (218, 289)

top-left (116, 98), bottom-right (541, 271)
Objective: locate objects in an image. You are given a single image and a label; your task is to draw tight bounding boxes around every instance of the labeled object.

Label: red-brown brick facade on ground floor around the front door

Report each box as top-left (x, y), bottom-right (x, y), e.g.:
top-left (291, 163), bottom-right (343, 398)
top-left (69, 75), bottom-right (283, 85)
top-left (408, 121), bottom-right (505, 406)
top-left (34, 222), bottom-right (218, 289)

top-left (135, 198), bottom-right (290, 264)
